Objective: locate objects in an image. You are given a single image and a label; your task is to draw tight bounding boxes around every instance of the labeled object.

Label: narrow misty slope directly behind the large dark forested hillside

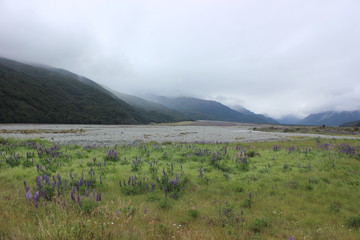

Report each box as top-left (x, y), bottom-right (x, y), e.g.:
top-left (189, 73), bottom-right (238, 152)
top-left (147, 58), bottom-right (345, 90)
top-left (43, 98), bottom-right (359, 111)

top-left (112, 91), bottom-right (195, 122)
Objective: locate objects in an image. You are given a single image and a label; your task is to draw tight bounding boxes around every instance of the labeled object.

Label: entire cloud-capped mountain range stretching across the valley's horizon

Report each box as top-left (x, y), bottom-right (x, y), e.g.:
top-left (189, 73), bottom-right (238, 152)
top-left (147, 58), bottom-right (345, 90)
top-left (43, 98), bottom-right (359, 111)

top-left (0, 55), bottom-right (360, 126)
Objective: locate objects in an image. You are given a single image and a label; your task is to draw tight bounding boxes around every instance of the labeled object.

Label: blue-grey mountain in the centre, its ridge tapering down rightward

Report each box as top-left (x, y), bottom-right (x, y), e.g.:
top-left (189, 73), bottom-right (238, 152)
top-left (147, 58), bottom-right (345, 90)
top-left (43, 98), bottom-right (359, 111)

top-left (146, 96), bottom-right (276, 123)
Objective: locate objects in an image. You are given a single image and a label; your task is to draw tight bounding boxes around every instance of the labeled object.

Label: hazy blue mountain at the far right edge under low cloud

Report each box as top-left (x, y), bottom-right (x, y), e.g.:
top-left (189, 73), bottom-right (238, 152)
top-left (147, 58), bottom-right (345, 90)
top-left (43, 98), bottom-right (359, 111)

top-left (299, 110), bottom-right (360, 126)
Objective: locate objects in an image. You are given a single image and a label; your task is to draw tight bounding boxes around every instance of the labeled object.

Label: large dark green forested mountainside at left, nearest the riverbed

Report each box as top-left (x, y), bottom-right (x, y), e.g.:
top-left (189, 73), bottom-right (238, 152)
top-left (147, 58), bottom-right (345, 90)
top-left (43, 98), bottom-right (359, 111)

top-left (0, 58), bottom-right (158, 124)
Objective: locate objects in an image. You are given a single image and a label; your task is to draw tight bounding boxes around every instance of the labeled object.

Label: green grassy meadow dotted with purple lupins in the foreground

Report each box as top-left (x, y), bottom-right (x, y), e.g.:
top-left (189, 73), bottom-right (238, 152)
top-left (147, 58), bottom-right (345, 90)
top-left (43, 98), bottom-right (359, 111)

top-left (0, 138), bottom-right (360, 240)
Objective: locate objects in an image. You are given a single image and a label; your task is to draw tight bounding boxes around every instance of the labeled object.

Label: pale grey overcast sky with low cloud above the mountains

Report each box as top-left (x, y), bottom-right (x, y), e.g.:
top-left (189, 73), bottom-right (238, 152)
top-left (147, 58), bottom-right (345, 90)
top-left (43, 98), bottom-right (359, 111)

top-left (0, 0), bottom-right (360, 118)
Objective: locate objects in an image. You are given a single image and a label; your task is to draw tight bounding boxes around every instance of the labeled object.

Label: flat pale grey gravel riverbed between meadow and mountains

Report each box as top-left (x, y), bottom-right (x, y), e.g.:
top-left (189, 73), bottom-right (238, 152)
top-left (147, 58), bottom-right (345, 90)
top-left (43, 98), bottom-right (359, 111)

top-left (0, 124), bottom-right (353, 145)
